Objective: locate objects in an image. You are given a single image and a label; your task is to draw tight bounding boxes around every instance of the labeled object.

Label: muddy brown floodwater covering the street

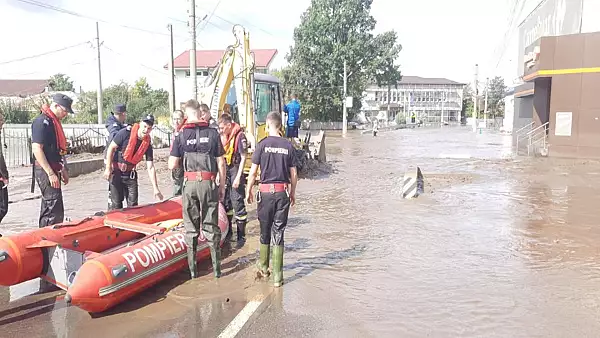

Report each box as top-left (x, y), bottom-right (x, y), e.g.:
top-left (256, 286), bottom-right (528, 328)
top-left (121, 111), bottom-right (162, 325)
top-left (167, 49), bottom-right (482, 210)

top-left (0, 127), bottom-right (600, 337)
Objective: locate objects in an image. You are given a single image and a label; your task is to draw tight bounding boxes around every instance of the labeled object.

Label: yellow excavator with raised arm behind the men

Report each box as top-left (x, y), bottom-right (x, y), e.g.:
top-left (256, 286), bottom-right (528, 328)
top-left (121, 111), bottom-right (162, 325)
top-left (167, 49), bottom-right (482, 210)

top-left (198, 25), bottom-right (326, 174)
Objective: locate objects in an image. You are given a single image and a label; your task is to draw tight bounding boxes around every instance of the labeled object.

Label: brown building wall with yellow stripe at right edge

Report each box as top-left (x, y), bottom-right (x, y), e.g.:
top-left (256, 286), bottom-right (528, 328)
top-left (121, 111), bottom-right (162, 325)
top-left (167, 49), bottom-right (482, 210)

top-left (524, 33), bottom-right (600, 158)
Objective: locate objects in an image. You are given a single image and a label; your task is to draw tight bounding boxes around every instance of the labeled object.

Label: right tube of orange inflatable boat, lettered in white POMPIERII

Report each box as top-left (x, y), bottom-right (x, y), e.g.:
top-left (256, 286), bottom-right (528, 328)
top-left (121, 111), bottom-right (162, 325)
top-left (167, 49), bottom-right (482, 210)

top-left (65, 204), bottom-right (229, 313)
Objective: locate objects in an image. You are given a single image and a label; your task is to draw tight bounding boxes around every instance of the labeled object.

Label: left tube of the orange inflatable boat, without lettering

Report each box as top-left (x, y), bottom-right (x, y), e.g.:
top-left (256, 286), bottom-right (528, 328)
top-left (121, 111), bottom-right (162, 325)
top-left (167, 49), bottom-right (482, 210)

top-left (0, 199), bottom-right (181, 289)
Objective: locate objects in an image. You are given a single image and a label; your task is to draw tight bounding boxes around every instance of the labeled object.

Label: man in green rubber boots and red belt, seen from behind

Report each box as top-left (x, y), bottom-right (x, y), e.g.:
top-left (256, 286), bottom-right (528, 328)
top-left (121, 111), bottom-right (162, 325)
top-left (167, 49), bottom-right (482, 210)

top-left (246, 112), bottom-right (298, 287)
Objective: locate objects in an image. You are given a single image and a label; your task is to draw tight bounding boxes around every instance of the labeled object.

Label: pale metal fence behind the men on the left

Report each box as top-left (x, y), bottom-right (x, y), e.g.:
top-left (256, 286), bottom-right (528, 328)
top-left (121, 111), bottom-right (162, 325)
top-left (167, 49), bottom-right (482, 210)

top-left (0, 124), bottom-right (172, 167)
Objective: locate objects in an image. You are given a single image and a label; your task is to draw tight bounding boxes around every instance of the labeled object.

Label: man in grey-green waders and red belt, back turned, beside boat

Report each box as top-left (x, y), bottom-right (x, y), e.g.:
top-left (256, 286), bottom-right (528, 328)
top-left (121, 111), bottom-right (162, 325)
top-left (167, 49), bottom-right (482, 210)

top-left (169, 100), bottom-right (225, 278)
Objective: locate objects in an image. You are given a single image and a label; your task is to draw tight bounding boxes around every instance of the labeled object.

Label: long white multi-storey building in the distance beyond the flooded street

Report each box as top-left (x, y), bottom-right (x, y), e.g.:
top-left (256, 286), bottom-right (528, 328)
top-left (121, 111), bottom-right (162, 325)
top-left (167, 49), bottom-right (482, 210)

top-left (357, 76), bottom-right (465, 123)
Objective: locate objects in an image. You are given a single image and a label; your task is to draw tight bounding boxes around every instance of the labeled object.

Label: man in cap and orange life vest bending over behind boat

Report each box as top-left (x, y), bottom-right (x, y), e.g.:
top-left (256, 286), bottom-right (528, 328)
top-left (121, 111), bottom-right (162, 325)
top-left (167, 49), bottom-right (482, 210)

top-left (104, 115), bottom-right (163, 210)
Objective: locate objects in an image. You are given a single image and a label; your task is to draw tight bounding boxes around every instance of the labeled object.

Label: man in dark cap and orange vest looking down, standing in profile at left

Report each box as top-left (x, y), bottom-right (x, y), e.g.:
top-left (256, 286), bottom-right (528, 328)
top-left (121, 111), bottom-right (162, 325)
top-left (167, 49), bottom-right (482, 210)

top-left (31, 94), bottom-right (73, 228)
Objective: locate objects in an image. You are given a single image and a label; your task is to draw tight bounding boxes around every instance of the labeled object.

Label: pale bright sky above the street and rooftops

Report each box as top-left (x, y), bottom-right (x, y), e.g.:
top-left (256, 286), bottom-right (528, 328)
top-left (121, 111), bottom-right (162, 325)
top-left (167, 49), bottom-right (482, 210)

top-left (0, 0), bottom-right (535, 90)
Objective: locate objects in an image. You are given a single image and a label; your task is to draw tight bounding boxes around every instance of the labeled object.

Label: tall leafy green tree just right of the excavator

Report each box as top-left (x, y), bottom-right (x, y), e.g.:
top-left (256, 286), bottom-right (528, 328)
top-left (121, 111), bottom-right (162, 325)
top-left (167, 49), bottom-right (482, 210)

top-left (282, 0), bottom-right (397, 121)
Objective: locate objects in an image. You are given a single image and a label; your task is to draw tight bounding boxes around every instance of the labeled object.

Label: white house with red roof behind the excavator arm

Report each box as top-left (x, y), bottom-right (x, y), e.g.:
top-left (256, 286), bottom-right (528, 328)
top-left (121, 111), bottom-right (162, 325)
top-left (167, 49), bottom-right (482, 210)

top-left (165, 49), bottom-right (277, 105)
